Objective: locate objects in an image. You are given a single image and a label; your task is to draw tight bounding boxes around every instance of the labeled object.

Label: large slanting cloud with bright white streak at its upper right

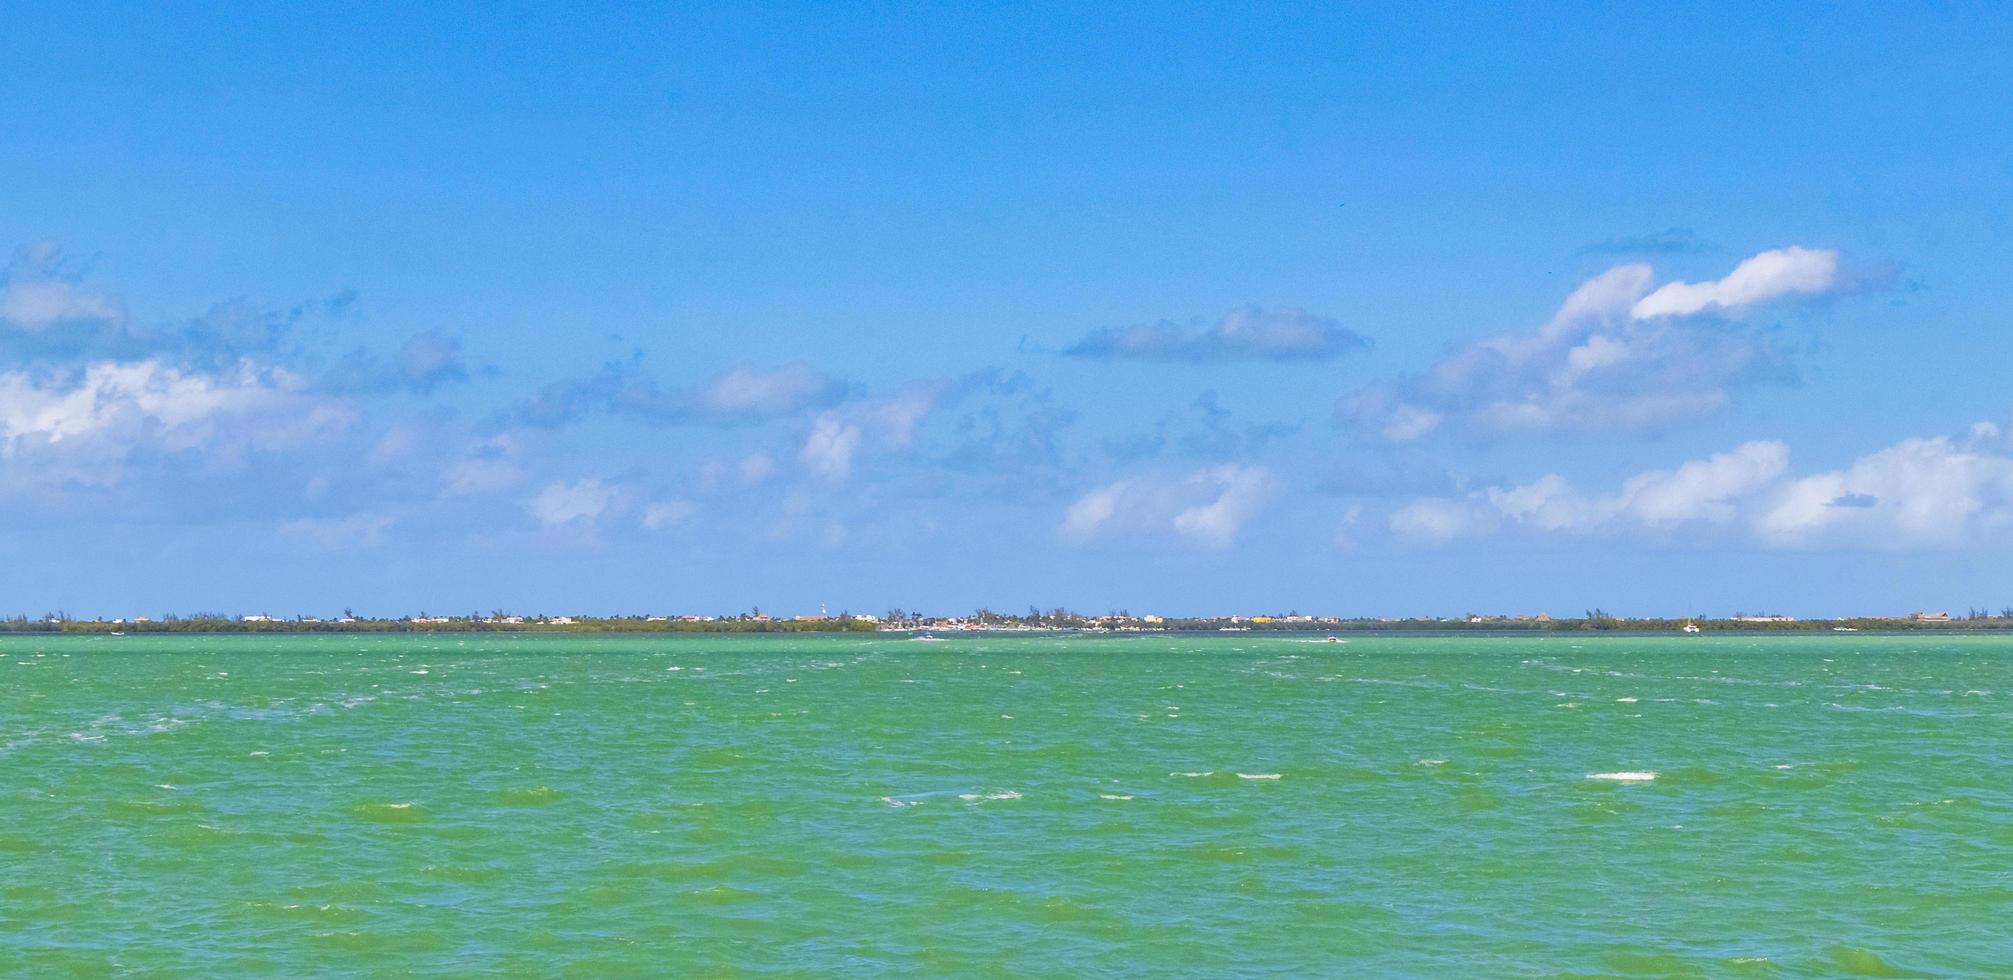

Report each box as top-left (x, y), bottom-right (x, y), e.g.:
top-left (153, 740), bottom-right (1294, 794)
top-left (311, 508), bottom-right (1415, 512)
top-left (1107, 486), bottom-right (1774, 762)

top-left (1337, 248), bottom-right (1838, 443)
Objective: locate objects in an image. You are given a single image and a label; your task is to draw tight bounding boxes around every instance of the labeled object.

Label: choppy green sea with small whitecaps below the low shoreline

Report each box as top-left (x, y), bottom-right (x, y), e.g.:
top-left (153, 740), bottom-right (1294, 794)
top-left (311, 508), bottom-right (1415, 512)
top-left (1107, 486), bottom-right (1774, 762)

top-left (0, 634), bottom-right (2013, 976)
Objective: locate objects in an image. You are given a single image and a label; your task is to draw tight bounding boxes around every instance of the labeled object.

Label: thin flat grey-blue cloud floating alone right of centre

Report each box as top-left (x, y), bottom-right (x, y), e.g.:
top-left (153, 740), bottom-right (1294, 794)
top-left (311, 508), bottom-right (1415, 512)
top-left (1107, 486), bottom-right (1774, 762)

top-left (1063, 306), bottom-right (1369, 362)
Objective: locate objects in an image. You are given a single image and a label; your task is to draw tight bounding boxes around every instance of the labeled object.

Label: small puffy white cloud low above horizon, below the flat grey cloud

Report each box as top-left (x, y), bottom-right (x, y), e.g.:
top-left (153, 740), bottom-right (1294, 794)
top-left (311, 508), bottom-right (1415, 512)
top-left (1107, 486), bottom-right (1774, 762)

top-left (1063, 465), bottom-right (1274, 547)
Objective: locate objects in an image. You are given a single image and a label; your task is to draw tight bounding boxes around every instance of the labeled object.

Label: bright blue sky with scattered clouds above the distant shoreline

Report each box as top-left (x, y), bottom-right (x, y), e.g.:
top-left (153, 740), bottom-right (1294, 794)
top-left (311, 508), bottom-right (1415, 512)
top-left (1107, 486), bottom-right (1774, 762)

top-left (0, 4), bottom-right (2013, 616)
